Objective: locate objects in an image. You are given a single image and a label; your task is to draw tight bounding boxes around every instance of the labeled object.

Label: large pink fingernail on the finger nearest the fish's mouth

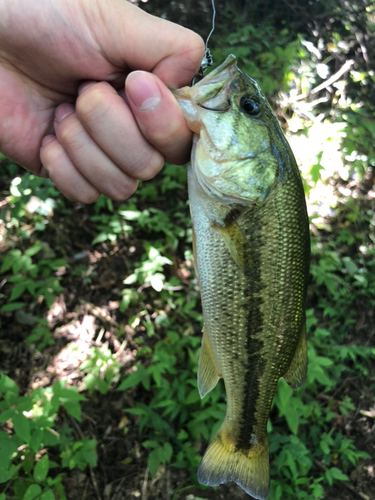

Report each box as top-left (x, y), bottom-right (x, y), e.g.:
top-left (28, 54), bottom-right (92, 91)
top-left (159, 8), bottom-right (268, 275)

top-left (126, 71), bottom-right (161, 111)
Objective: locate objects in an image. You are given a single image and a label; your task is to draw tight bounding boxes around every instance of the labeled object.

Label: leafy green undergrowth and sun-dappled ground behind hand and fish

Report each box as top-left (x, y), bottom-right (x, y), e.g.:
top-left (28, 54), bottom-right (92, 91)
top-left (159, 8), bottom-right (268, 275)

top-left (0, 0), bottom-right (375, 500)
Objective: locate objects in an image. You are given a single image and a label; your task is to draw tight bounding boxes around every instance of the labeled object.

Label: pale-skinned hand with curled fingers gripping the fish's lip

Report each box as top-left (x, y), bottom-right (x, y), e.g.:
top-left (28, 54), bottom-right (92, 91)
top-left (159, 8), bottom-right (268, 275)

top-left (0, 0), bottom-right (204, 203)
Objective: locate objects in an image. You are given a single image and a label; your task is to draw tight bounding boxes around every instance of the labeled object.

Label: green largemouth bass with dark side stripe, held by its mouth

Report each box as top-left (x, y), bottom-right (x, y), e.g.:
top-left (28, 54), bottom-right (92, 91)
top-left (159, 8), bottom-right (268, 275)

top-left (175, 56), bottom-right (310, 499)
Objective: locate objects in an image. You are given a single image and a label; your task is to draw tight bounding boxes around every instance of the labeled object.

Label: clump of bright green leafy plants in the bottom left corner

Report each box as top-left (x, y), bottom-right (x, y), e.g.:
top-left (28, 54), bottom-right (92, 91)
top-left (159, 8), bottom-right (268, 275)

top-left (0, 374), bottom-right (97, 500)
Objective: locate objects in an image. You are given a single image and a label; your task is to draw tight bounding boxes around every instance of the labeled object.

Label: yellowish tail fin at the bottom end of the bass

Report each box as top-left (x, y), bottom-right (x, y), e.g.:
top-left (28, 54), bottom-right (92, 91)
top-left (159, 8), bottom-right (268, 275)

top-left (198, 427), bottom-right (270, 500)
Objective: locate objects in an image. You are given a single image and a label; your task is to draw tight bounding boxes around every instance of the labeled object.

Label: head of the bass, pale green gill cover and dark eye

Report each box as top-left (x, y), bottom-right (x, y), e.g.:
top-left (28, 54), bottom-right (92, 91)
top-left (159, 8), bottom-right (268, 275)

top-left (174, 55), bottom-right (282, 204)
